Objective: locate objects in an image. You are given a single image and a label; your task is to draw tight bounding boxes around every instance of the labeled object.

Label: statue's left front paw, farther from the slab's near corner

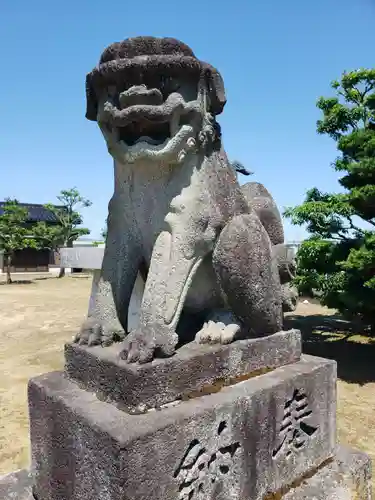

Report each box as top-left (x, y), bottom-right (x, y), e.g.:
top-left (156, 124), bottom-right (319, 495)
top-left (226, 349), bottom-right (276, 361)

top-left (74, 317), bottom-right (125, 347)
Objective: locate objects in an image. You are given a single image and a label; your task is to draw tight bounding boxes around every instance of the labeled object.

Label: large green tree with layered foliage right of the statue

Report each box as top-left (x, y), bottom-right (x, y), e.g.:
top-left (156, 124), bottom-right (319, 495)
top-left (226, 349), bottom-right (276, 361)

top-left (284, 69), bottom-right (375, 331)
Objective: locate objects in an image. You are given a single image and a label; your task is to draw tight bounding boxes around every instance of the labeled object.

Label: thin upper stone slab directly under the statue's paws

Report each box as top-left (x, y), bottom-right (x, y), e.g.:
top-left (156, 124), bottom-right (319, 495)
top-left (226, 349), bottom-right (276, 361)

top-left (65, 330), bottom-right (301, 411)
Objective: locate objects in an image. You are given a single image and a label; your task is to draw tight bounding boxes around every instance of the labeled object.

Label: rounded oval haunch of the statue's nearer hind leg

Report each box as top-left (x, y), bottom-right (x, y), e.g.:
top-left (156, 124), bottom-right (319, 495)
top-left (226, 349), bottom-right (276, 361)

top-left (212, 212), bottom-right (283, 338)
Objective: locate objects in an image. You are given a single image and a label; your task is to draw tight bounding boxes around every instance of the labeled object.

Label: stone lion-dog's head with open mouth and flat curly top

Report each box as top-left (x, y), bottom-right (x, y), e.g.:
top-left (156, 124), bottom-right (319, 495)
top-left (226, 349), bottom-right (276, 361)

top-left (86, 37), bottom-right (226, 164)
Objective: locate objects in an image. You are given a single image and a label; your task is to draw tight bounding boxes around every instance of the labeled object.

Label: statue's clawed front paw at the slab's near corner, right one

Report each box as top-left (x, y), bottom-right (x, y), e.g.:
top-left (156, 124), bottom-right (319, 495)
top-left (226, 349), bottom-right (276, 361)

top-left (121, 324), bottom-right (178, 364)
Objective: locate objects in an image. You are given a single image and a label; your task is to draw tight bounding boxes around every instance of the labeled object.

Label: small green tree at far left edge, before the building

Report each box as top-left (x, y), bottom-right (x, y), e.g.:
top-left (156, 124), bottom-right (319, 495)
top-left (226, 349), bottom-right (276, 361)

top-left (0, 199), bottom-right (36, 284)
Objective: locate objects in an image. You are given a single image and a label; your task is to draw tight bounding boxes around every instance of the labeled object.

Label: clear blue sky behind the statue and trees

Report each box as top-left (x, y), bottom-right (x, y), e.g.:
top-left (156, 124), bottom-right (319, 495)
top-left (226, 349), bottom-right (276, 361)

top-left (0, 0), bottom-right (375, 240)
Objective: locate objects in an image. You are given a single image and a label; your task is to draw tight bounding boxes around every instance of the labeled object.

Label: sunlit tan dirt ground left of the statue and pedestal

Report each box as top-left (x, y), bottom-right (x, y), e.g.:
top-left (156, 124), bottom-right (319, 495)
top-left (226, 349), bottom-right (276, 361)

top-left (0, 276), bottom-right (91, 475)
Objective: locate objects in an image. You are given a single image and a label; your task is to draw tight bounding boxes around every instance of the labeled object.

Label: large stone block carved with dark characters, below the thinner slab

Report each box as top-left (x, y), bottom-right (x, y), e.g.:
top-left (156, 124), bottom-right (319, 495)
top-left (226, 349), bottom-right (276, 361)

top-left (29, 356), bottom-right (336, 500)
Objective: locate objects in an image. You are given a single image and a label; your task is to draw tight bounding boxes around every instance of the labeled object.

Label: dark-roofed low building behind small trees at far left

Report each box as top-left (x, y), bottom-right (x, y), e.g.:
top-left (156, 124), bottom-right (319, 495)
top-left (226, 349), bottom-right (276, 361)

top-left (0, 201), bottom-right (63, 273)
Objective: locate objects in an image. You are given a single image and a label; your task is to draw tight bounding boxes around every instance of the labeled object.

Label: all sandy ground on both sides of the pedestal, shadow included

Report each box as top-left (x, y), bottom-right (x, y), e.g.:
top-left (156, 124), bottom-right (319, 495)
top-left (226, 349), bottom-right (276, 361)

top-left (0, 276), bottom-right (375, 488)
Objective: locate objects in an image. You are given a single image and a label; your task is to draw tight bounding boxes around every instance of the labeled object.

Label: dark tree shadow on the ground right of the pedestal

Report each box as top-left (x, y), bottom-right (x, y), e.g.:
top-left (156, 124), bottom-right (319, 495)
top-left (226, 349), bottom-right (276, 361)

top-left (285, 314), bottom-right (375, 385)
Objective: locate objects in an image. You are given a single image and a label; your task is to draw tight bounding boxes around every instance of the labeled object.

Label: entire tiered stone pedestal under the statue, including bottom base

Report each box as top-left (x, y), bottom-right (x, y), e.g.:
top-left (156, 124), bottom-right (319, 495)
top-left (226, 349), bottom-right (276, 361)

top-left (0, 330), bottom-right (371, 500)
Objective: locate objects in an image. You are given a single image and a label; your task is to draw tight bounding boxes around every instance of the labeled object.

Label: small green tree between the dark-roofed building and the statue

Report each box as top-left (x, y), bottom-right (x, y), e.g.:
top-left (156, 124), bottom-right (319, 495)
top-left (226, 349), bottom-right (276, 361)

top-left (34, 188), bottom-right (92, 277)
